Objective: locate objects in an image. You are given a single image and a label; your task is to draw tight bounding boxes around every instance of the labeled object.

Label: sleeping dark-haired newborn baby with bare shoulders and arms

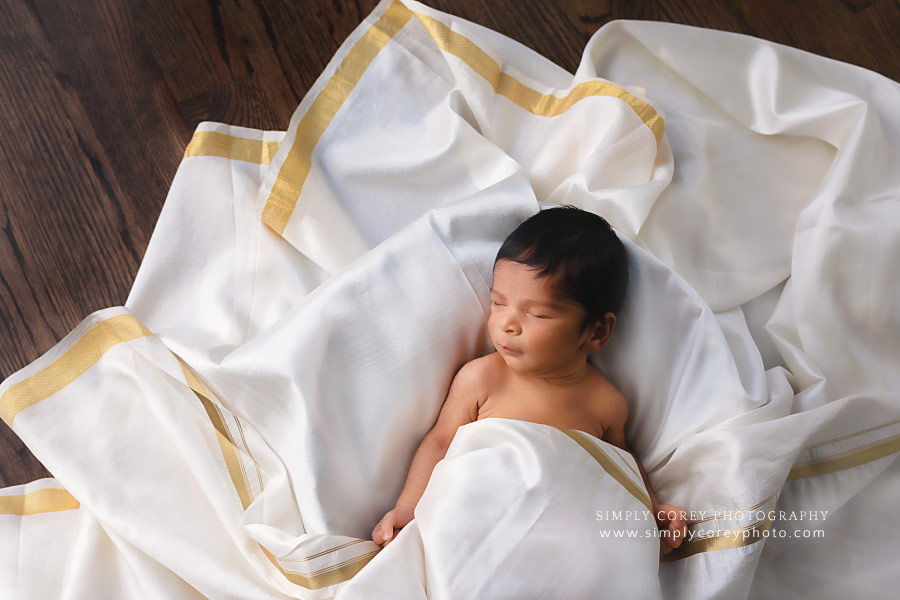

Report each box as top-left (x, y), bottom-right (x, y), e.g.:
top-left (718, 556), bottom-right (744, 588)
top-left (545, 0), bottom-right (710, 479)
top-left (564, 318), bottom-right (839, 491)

top-left (372, 205), bottom-right (687, 554)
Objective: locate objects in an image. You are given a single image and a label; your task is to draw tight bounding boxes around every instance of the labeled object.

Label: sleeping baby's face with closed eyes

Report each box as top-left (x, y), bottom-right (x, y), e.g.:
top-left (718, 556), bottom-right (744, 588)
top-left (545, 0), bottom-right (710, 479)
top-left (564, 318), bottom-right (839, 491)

top-left (488, 260), bottom-right (593, 376)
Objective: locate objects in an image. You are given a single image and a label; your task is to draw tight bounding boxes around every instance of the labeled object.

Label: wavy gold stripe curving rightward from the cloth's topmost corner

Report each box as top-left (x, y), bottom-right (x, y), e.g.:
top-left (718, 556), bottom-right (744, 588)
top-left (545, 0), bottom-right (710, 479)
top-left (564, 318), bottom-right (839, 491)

top-left (413, 13), bottom-right (665, 145)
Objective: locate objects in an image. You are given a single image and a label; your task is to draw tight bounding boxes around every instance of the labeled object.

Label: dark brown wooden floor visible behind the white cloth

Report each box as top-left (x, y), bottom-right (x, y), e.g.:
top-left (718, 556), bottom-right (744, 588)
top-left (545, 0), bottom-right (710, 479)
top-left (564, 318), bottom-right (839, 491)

top-left (0, 0), bottom-right (900, 487)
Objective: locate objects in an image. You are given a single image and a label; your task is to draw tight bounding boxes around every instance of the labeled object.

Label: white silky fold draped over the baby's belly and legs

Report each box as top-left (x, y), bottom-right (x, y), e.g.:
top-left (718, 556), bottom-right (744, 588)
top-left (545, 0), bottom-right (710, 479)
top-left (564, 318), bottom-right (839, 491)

top-left (339, 418), bottom-right (660, 600)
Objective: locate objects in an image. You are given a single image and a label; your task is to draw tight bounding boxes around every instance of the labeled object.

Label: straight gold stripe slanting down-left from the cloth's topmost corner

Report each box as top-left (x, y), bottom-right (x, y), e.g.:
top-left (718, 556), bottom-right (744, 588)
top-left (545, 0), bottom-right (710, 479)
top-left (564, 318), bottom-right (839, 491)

top-left (262, 1), bottom-right (412, 234)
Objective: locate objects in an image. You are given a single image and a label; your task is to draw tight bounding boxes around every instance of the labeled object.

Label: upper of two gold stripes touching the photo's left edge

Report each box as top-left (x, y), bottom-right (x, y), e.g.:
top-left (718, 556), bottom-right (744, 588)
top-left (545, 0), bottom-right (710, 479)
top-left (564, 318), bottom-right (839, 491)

top-left (0, 314), bottom-right (153, 427)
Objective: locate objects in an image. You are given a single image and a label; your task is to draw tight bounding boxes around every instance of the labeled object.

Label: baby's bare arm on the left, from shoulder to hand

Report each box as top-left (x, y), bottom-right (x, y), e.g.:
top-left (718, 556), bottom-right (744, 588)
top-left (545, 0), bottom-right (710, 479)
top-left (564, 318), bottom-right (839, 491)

top-left (372, 359), bottom-right (484, 547)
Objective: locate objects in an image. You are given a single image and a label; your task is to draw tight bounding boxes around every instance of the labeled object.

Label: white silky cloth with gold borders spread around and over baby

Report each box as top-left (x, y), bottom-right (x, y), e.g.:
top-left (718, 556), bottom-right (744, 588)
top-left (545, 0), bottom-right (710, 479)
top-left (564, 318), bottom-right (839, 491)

top-left (0, 0), bottom-right (900, 598)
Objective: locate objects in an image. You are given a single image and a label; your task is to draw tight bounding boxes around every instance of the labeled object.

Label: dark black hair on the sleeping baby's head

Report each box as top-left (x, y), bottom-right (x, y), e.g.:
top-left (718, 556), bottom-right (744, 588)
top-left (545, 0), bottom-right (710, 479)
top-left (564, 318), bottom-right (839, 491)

top-left (494, 204), bottom-right (628, 332)
